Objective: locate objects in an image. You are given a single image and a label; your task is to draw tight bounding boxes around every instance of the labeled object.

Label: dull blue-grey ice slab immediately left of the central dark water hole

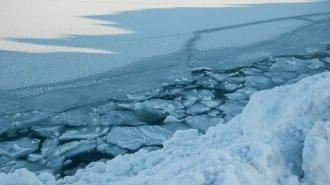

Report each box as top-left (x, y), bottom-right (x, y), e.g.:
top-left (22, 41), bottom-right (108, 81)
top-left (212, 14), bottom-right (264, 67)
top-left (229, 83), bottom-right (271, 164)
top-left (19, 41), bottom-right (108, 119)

top-left (101, 111), bottom-right (144, 126)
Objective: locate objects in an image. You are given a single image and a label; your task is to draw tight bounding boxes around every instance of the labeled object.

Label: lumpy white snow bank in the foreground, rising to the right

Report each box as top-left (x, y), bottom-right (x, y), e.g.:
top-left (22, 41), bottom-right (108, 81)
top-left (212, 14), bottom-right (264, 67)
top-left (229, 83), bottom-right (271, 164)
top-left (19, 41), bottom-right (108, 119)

top-left (0, 72), bottom-right (330, 185)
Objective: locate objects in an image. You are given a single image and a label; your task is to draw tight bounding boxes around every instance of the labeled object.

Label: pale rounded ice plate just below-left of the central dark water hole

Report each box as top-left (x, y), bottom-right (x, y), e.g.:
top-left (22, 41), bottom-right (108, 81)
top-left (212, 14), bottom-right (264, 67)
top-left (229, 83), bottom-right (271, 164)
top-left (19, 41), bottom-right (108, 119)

top-left (107, 126), bottom-right (146, 150)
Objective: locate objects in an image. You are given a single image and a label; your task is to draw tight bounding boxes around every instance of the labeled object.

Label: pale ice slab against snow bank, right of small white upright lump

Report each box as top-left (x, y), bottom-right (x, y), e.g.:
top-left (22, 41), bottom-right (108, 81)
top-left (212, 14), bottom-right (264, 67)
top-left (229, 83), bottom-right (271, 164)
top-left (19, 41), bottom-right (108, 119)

top-left (185, 114), bottom-right (224, 133)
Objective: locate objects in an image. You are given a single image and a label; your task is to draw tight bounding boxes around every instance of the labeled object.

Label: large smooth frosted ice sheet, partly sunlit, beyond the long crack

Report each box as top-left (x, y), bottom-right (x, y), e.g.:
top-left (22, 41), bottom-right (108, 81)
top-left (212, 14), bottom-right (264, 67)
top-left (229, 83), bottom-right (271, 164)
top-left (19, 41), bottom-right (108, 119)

top-left (0, 0), bottom-right (329, 89)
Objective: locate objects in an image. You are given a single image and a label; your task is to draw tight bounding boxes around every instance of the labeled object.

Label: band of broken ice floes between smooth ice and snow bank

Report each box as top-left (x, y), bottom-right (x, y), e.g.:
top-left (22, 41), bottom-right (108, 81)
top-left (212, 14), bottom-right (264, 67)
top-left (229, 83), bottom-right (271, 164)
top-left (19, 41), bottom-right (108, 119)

top-left (0, 51), bottom-right (330, 175)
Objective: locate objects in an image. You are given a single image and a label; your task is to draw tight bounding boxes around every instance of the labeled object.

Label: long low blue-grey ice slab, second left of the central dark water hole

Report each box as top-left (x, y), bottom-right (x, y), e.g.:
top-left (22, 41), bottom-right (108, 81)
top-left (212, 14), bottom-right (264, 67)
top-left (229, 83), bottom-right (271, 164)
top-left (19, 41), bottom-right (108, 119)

top-left (49, 110), bottom-right (100, 126)
